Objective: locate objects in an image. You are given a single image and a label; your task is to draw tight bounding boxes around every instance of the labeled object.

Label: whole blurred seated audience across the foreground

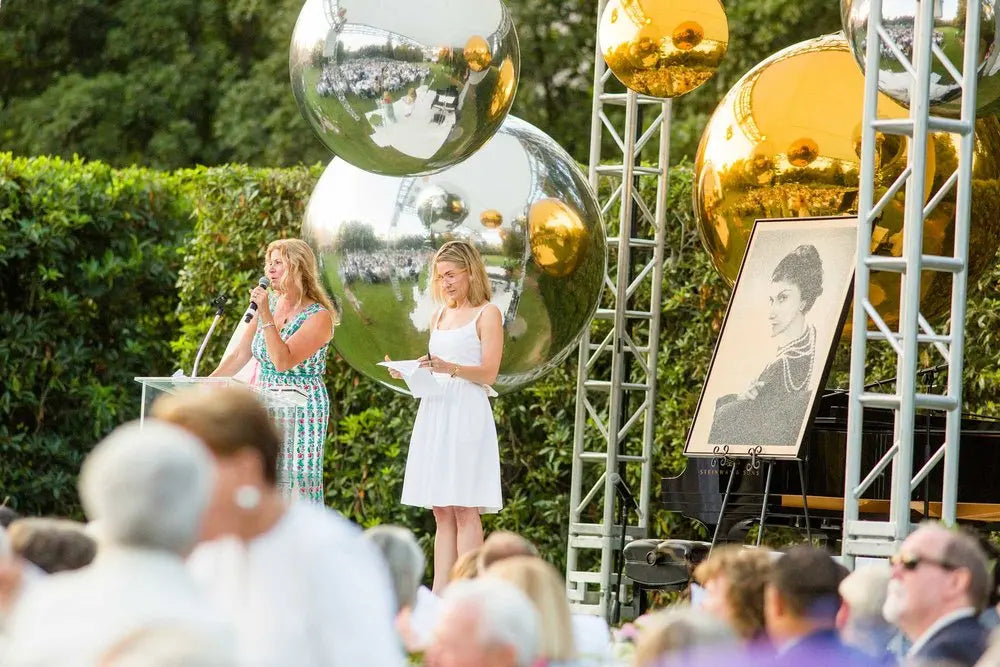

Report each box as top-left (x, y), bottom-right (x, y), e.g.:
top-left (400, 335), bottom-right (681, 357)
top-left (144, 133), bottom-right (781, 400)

top-left (0, 388), bottom-right (1000, 667)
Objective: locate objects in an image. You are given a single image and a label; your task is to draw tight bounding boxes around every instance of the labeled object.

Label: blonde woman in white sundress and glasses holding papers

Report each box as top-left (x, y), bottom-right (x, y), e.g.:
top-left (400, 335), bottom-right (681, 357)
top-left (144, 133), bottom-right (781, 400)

top-left (388, 241), bottom-right (503, 593)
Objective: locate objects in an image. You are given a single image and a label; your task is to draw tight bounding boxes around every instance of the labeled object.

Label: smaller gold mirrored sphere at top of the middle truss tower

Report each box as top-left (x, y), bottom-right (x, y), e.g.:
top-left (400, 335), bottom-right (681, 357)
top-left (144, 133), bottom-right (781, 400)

top-left (598, 0), bottom-right (729, 97)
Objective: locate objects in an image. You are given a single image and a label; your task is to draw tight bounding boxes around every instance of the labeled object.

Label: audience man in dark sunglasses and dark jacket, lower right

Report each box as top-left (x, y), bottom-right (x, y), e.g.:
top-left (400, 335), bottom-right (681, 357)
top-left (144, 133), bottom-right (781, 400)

top-left (882, 523), bottom-right (991, 666)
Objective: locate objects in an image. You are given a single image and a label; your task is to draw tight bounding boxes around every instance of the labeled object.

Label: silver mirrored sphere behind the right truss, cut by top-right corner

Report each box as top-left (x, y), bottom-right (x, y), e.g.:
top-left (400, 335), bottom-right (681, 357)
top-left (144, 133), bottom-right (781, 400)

top-left (840, 0), bottom-right (1000, 117)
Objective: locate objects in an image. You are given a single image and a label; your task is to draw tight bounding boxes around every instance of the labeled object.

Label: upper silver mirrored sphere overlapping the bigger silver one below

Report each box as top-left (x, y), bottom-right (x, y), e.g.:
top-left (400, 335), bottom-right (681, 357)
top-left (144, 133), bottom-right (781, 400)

top-left (289, 0), bottom-right (520, 176)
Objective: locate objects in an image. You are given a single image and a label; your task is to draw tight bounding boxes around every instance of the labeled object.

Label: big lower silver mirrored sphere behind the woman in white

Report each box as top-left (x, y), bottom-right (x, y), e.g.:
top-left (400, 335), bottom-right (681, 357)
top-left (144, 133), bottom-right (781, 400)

top-left (302, 117), bottom-right (607, 392)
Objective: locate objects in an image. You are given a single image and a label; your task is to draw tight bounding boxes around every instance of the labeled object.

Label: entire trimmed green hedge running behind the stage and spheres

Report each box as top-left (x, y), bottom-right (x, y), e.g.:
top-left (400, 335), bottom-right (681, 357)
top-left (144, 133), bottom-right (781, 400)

top-left (0, 155), bottom-right (1000, 565)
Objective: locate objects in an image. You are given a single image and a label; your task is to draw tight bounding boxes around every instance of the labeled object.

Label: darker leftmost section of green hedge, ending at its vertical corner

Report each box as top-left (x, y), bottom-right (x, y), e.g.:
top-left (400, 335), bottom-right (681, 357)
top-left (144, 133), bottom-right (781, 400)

top-left (0, 153), bottom-right (191, 515)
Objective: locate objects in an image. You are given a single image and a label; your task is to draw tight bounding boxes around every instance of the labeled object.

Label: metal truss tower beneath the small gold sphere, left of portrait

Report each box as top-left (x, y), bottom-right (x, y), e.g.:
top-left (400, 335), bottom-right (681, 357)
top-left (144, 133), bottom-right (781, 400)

top-left (566, 0), bottom-right (671, 616)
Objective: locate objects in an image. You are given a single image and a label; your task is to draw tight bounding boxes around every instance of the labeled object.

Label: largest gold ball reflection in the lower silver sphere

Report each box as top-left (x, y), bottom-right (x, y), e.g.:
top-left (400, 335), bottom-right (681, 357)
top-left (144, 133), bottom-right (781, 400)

top-left (528, 197), bottom-right (587, 278)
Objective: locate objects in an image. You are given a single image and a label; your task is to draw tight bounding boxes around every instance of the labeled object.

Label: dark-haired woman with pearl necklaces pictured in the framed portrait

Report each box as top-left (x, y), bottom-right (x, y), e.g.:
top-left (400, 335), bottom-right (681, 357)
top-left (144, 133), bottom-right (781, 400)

top-left (708, 244), bottom-right (823, 446)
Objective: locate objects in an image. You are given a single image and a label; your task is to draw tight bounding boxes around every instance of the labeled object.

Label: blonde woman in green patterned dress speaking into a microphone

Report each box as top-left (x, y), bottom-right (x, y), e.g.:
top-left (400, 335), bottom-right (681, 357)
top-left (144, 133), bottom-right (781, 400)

top-left (212, 239), bottom-right (337, 504)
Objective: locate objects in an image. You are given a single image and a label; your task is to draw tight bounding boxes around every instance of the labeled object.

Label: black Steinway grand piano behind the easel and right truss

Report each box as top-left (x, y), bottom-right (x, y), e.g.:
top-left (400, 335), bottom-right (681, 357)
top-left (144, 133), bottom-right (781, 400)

top-left (661, 392), bottom-right (1000, 541)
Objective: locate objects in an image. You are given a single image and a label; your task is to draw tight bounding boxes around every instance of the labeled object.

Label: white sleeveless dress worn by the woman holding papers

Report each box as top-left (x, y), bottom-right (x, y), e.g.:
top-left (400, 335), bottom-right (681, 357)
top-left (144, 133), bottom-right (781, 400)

top-left (402, 304), bottom-right (503, 513)
